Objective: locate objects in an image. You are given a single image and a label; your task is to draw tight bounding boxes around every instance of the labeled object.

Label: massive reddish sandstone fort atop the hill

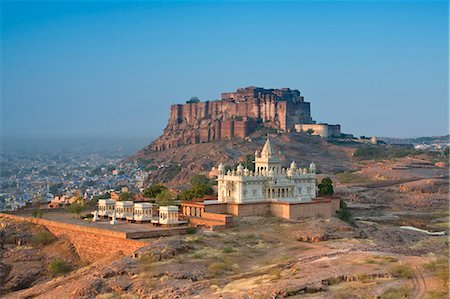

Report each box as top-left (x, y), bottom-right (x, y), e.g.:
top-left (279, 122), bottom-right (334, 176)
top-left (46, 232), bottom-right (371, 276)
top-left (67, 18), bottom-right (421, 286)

top-left (151, 86), bottom-right (341, 151)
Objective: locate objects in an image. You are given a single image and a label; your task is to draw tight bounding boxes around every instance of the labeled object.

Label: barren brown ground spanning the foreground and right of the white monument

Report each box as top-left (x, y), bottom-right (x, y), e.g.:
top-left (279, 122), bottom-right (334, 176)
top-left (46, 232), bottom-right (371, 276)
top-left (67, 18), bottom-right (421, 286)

top-left (1, 154), bottom-right (449, 299)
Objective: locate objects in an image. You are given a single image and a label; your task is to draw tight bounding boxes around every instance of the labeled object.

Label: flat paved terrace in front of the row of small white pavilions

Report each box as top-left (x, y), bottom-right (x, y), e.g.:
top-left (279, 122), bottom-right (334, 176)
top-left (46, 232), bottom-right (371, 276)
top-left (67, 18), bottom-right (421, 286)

top-left (0, 209), bottom-right (187, 239)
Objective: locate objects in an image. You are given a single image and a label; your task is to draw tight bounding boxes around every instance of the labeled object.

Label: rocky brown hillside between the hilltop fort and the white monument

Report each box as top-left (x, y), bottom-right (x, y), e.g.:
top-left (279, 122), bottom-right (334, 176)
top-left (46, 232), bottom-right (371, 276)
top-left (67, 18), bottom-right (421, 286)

top-left (130, 129), bottom-right (355, 185)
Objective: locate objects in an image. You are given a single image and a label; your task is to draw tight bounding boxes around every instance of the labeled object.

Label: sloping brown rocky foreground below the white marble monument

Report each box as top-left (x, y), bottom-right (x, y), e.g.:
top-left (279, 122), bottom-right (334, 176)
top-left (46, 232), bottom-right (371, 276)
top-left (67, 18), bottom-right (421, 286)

top-left (2, 217), bottom-right (447, 298)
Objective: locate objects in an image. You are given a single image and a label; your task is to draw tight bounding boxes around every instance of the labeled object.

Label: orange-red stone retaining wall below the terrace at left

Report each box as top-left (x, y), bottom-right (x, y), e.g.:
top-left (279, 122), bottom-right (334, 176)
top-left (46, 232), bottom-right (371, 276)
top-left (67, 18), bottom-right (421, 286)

top-left (0, 213), bottom-right (149, 263)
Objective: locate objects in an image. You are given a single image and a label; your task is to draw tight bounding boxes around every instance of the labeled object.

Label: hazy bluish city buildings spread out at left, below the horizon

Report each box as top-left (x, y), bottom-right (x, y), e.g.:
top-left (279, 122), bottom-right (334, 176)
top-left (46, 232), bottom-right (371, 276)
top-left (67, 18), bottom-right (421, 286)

top-left (0, 146), bottom-right (149, 211)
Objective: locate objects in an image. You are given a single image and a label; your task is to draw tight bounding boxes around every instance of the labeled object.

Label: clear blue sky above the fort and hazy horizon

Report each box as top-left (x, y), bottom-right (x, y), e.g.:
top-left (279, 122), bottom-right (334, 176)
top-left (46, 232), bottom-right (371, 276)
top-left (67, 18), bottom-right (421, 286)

top-left (1, 1), bottom-right (449, 138)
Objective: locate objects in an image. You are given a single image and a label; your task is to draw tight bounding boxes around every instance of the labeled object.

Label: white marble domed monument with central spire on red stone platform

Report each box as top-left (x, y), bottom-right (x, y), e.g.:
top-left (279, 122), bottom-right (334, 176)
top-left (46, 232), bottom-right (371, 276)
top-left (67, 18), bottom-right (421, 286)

top-left (181, 139), bottom-right (339, 226)
